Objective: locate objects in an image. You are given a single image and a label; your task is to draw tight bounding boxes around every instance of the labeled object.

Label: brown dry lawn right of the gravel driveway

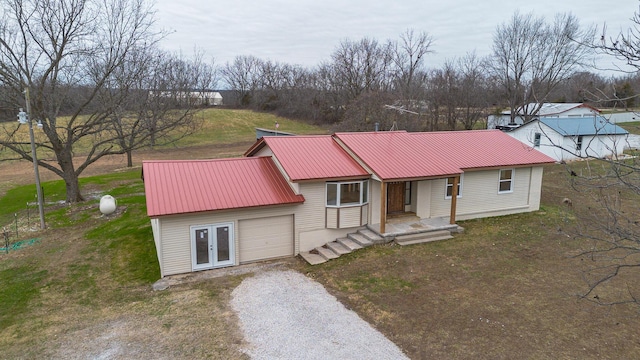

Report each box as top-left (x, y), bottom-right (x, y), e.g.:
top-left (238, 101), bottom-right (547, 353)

top-left (300, 165), bottom-right (640, 359)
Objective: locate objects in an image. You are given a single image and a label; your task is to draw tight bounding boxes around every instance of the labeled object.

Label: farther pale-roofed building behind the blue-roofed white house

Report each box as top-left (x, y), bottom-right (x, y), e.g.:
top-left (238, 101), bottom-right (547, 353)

top-left (487, 103), bottom-right (600, 129)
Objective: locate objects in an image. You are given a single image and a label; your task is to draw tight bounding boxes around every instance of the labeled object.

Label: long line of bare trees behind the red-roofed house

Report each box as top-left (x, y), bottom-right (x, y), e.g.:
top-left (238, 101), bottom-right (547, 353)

top-left (220, 13), bottom-right (640, 131)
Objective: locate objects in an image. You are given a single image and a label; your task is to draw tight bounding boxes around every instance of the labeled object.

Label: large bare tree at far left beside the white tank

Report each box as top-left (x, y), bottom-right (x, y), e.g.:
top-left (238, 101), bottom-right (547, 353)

top-left (0, 0), bottom-right (160, 202)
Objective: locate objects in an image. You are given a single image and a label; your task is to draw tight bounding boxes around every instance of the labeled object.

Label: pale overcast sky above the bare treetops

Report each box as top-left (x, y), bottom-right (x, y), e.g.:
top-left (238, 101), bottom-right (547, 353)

top-left (156, 0), bottom-right (640, 74)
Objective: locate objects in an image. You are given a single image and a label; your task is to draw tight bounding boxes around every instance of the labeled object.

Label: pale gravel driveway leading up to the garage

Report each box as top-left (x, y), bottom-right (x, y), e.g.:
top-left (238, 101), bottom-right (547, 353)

top-left (231, 270), bottom-right (407, 359)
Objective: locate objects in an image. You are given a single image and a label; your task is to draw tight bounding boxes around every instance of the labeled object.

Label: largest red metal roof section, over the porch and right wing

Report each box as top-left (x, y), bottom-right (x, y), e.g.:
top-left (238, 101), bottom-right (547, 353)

top-left (335, 130), bottom-right (554, 180)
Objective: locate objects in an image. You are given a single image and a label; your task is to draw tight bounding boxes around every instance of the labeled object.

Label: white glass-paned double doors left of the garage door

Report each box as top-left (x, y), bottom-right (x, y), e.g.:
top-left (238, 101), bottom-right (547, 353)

top-left (191, 223), bottom-right (235, 270)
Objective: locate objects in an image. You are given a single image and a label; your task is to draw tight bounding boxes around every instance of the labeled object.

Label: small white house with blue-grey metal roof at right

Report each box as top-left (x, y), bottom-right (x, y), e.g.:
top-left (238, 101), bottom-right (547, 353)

top-left (507, 116), bottom-right (629, 161)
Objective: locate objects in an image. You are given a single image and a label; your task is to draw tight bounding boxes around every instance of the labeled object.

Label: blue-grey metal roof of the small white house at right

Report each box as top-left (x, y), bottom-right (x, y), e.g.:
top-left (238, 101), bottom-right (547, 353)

top-left (539, 116), bottom-right (629, 136)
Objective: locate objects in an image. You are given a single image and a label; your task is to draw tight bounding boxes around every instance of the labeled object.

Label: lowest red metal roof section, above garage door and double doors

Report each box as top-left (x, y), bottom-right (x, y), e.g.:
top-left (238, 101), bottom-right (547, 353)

top-left (142, 157), bottom-right (304, 216)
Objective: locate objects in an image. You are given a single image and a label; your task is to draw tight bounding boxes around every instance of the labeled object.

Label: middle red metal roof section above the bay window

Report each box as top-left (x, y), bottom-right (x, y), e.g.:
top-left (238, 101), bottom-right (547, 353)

top-left (245, 135), bottom-right (370, 182)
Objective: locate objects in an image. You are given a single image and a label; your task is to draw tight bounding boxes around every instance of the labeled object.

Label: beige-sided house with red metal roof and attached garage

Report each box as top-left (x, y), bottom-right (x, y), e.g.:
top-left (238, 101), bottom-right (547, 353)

top-left (143, 130), bottom-right (553, 277)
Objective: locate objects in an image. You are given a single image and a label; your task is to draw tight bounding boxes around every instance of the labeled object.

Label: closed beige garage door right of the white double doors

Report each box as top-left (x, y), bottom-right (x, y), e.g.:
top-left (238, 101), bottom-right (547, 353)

top-left (238, 215), bottom-right (293, 263)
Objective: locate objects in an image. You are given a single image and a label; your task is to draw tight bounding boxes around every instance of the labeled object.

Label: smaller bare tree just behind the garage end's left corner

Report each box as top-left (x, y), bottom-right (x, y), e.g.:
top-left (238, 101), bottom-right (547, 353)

top-left (109, 50), bottom-right (216, 167)
